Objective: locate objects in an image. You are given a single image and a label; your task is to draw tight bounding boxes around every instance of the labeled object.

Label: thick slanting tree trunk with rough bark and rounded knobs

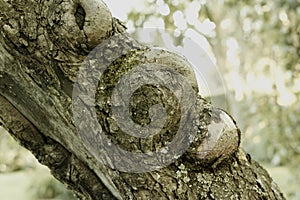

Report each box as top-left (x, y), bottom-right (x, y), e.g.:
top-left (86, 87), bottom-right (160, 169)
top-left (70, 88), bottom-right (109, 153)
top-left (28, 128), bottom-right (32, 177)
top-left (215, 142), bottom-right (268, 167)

top-left (0, 0), bottom-right (284, 199)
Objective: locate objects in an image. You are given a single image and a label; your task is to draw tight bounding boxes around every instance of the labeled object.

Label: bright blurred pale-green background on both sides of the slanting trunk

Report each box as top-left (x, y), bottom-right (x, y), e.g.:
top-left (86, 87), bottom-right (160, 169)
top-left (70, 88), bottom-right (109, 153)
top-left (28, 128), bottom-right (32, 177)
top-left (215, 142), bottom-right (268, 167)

top-left (0, 0), bottom-right (300, 200)
